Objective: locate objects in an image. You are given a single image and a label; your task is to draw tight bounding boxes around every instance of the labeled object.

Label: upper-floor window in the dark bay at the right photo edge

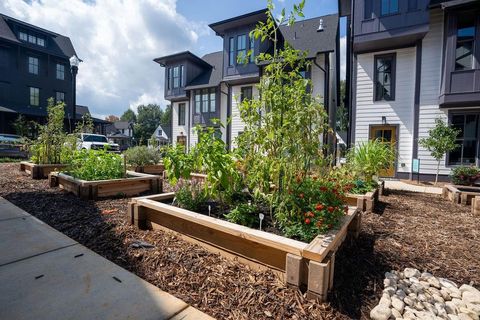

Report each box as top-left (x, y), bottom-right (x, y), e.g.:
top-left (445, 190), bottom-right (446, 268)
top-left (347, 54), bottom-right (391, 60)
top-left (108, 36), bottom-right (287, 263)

top-left (455, 15), bottom-right (475, 70)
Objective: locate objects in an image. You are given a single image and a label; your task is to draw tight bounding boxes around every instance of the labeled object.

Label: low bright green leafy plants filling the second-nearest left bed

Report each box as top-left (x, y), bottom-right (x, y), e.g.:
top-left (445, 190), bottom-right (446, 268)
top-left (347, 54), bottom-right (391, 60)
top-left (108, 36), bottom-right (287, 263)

top-left (67, 149), bottom-right (125, 181)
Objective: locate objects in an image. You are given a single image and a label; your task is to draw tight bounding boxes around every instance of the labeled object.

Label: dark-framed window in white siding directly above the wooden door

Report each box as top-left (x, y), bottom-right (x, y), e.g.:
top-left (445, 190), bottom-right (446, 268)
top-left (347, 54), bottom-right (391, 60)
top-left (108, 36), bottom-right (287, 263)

top-left (374, 54), bottom-right (395, 101)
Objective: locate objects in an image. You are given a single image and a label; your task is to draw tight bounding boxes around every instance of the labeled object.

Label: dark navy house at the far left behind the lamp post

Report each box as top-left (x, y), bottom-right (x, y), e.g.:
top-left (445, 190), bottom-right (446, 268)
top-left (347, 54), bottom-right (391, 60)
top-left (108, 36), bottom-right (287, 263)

top-left (0, 14), bottom-right (76, 133)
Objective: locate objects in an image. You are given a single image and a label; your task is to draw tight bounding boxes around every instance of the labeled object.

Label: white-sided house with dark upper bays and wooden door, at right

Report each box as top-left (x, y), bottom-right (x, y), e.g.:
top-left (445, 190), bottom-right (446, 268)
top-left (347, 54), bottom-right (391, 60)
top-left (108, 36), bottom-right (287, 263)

top-left (339, 0), bottom-right (480, 179)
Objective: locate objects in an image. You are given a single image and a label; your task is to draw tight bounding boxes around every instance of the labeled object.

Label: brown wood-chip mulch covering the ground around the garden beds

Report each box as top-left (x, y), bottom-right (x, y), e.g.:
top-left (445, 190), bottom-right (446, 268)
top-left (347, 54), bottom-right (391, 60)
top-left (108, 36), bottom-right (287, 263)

top-left (0, 164), bottom-right (480, 319)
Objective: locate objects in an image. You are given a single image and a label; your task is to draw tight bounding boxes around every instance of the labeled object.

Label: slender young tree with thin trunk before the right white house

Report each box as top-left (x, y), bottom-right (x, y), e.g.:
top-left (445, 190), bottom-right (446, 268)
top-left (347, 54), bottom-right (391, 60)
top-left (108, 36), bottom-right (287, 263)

top-left (418, 118), bottom-right (460, 185)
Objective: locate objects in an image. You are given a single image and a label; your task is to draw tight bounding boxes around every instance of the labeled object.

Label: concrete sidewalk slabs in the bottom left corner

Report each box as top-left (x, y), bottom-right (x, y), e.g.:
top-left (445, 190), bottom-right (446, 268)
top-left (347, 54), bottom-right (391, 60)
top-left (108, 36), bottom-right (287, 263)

top-left (0, 197), bottom-right (213, 320)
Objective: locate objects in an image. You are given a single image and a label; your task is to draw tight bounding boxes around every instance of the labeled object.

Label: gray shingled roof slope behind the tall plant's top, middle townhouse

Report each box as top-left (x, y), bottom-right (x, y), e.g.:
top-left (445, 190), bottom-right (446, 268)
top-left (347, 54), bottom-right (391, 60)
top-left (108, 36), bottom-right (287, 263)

top-left (280, 14), bottom-right (338, 58)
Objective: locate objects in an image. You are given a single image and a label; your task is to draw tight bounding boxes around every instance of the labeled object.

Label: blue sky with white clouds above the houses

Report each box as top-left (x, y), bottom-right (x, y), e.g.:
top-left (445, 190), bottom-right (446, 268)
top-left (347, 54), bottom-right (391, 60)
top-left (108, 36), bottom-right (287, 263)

top-left (0, 0), bottom-right (345, 118)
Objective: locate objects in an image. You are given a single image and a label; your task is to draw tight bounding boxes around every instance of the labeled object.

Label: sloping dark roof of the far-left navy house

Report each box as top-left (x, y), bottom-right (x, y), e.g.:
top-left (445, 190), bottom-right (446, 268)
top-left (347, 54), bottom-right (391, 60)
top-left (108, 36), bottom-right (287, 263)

top-left (0, 13), bottom-right (76, 58)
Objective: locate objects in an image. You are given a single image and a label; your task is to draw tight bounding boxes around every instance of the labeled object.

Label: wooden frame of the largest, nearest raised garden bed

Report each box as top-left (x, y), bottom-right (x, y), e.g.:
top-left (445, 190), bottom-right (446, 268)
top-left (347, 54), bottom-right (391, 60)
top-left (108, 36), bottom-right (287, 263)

top-left (128, 192), bottom-right (361, 301)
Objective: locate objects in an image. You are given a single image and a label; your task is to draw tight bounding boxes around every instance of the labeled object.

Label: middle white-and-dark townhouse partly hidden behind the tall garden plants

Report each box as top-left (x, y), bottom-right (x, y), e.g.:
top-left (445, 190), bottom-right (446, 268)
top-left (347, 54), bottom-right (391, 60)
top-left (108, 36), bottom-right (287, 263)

top-left (154, 9), bottom-right (339, 149)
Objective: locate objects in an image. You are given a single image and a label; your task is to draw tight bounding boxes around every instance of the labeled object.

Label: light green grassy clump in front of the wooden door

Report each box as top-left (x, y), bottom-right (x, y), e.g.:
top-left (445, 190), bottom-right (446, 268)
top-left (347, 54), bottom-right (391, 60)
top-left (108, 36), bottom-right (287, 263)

top-left (347, 139), bottom-right (395, 184)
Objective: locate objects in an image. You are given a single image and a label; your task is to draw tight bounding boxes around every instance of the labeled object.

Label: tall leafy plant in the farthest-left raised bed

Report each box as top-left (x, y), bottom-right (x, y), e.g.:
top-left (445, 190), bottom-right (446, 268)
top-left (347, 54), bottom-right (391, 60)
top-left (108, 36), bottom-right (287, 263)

top-left (30, 98), bottom-right (66, 164)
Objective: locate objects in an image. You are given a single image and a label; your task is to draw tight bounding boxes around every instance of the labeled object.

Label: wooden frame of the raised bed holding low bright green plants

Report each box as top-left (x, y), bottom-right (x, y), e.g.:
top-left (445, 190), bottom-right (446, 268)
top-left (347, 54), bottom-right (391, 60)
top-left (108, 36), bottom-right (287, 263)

top-left (49, 171), bottom-right (162, 200)
